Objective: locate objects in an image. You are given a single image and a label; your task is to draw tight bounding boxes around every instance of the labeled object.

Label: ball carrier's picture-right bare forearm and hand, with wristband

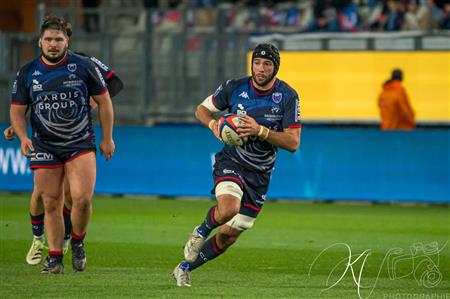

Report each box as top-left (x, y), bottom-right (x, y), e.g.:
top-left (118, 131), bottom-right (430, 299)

top-left (238, 115), bottom-right (301, 152)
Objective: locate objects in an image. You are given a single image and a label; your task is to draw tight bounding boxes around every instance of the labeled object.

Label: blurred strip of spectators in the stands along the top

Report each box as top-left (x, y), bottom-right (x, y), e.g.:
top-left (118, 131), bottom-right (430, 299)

top-left (75, 0), bottom-right (450, 33)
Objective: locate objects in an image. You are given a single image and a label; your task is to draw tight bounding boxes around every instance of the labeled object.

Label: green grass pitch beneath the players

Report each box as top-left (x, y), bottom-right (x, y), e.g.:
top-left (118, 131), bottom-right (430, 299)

top-left (0, 194), bottom-right (450, 298)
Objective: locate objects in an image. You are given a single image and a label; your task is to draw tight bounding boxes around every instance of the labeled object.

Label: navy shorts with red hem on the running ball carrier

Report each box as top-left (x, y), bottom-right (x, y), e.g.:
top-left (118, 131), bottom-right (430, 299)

top-left (211, 152), bottom-right (271, 218)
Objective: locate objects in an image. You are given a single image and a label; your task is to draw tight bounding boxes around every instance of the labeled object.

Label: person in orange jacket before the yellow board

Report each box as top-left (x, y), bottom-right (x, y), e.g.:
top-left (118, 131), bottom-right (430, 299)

top-left (378, 69), bottom-right (416, 130)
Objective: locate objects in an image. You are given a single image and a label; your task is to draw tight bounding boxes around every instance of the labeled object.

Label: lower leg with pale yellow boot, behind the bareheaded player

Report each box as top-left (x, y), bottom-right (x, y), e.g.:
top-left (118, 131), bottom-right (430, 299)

top-left (26, 187), bottom-right (45, 265)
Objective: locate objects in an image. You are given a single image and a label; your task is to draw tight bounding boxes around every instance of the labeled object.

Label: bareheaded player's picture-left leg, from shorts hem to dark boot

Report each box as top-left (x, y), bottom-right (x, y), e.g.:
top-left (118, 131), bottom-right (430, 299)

top-left (34, 167), bottom-right (64, 274)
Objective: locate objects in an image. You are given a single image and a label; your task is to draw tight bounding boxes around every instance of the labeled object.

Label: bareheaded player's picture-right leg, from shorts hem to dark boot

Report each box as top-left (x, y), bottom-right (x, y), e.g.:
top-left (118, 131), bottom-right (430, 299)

top-left (65, 151), bottom-right (96, 271)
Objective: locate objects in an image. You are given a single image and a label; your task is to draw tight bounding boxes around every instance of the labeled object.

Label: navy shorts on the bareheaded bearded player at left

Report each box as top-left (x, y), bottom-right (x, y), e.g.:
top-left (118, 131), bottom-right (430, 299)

top-left (30, 138), bottom-right (96, 169)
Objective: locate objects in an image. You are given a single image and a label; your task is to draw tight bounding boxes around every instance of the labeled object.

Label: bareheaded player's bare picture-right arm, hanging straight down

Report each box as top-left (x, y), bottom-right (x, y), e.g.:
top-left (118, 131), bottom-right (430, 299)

top-left (92, 92), bottom-right (115, 160)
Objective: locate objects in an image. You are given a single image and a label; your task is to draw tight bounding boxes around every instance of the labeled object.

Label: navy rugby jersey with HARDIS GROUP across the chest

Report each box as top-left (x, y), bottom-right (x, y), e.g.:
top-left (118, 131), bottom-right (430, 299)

top-left (11, 51), bottom-right (108, 146)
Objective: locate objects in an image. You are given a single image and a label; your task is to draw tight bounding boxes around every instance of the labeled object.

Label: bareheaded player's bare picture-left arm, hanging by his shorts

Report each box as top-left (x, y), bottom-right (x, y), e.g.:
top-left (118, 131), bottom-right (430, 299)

top-left (10, 105), bottom-right (34, 158)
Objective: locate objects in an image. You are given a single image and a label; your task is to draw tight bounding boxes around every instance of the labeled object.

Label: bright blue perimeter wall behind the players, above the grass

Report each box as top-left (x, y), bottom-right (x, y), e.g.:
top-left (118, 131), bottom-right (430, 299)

top-left (0, 124), bottom-right (450, 203)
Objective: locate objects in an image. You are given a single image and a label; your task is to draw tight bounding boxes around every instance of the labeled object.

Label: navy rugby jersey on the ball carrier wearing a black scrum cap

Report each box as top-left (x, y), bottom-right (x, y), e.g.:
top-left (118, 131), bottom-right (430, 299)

top-left (212, 77), bottom-right (301, 172)
